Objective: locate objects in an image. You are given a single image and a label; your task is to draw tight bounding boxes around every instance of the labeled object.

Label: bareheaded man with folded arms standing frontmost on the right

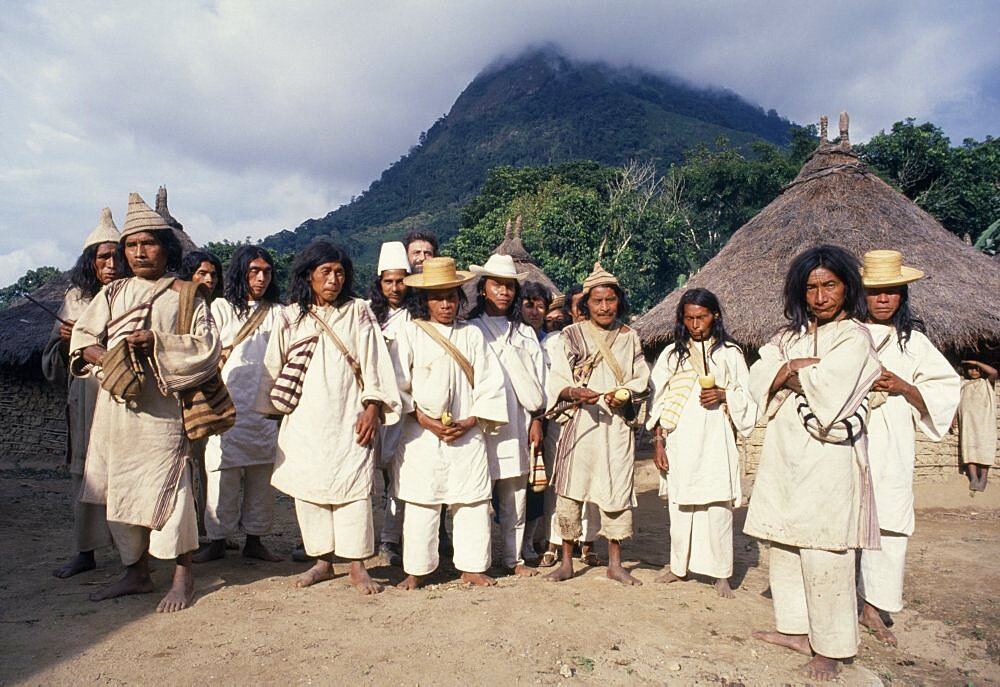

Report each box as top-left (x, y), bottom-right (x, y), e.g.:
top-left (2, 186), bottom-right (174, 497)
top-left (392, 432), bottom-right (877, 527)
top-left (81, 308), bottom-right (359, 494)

top-left (743, 245), bottom-right (881, 680)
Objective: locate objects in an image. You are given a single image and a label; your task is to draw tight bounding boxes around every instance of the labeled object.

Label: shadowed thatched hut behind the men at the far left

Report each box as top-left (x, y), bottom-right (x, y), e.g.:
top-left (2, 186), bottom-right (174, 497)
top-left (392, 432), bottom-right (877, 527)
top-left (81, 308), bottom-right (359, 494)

top-left (0, 186), bottom-right (196, 465)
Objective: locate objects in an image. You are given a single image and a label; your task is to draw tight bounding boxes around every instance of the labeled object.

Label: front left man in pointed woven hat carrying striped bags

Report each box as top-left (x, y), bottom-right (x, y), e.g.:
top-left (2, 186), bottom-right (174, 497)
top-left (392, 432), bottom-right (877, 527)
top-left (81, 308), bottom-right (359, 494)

top-left (70, 193), bottom-right (219, 612)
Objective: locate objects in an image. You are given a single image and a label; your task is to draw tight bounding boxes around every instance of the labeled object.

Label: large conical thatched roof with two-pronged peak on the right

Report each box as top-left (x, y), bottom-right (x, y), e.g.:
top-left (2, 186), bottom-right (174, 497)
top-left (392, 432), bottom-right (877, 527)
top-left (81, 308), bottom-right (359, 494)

top-left (635, 116), bottom-right (1000, 352)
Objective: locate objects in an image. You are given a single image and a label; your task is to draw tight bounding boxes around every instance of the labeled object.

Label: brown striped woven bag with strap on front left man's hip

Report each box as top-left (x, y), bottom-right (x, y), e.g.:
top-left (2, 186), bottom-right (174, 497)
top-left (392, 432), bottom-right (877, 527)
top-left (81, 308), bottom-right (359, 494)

top-left (175, 280), bottom-right (236, 441)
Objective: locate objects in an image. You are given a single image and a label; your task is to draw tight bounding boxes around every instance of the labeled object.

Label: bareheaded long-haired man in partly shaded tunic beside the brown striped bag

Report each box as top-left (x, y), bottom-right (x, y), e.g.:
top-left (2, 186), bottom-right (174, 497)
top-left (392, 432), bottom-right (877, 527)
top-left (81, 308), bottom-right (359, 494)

top-left (194, 246), bottom-right (281, 563)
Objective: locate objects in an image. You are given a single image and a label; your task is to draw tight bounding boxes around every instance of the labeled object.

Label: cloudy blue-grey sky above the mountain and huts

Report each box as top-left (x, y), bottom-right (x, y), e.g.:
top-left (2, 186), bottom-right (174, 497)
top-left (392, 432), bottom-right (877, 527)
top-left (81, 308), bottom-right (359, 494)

top-left (0, 0), bottom-right (1000, 286)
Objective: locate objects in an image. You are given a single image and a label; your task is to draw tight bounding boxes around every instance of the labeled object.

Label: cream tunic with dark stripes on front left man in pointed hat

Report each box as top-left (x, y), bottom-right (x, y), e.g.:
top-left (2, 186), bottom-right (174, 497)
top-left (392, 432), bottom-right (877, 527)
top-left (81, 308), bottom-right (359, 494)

top-left (70, 277), bottom-right (219, 529)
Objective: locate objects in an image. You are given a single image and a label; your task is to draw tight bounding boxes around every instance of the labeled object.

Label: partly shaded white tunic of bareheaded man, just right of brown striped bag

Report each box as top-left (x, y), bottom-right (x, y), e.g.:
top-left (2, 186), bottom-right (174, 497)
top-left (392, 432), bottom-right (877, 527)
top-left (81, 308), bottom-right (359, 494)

top-left (205, 298), bottom-right (281, 472)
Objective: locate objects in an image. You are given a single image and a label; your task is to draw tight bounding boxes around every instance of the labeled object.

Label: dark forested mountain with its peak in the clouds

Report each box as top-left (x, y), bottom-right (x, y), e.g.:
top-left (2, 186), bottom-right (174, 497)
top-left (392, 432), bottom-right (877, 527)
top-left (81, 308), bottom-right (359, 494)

top-left (264, 48), bottom-right (791, 264)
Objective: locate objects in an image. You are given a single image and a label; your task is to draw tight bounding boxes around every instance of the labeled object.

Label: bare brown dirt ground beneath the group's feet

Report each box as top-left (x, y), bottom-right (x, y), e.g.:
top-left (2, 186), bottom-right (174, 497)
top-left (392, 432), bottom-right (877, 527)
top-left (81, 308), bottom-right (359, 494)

top-left (0, 460), bottom-right (1000, 685)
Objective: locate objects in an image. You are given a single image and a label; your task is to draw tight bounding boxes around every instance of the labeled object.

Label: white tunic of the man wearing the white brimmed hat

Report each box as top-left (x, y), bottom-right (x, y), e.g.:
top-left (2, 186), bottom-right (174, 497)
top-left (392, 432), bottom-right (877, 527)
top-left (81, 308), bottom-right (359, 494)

top-left (470, 315), bottom-right (545, 480)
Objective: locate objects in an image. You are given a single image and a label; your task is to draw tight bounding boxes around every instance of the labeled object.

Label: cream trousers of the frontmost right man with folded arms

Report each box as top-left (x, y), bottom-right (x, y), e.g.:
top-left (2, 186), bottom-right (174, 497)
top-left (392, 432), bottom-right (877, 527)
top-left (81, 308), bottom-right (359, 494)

top-left (770, 542), bottom-right (858, 658)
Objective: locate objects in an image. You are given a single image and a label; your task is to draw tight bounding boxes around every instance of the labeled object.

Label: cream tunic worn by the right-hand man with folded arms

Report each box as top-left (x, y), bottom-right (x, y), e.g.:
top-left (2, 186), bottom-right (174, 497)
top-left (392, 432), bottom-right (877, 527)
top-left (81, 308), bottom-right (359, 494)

top-left (743, 319), bottom-right (881, 551)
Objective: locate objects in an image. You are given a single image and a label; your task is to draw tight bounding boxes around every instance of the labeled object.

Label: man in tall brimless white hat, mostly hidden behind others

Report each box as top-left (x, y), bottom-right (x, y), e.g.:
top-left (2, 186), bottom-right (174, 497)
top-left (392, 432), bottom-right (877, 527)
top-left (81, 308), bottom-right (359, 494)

top-left (368, 241), bottom-right (412, 565)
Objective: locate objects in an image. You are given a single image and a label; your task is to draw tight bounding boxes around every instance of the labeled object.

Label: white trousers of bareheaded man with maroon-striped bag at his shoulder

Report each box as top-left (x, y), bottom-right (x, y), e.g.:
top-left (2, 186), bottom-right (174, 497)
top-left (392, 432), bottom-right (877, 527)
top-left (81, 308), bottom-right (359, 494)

top-left (295, 496), bottom-right (375, 560)
